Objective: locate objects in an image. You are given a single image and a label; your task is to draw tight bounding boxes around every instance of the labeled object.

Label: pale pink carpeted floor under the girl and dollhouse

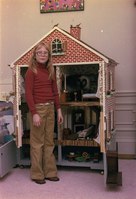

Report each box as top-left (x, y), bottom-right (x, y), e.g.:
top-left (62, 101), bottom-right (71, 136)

top-left (0, 160), bottom-right (136, 199)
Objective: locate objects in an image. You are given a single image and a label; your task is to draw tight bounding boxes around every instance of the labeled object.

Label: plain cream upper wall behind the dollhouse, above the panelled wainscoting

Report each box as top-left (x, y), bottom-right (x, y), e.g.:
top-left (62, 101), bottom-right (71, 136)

top-left (0, 0), bottom-right (136, 155)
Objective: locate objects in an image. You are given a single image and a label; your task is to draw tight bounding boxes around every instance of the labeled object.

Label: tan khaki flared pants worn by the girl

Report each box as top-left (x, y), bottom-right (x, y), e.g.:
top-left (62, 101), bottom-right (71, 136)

top-left (30, 104), bottom-right (57, 180)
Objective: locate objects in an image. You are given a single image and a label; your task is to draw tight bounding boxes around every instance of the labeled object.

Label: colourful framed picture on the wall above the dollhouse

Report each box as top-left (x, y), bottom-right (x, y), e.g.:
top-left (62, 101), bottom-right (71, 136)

top-left (40, 0), bottom-right (84, 13)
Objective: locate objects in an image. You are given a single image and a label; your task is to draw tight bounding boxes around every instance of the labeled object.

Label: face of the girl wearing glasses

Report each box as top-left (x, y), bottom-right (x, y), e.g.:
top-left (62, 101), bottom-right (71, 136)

top-left (35, 46), bottom-right (49, 64)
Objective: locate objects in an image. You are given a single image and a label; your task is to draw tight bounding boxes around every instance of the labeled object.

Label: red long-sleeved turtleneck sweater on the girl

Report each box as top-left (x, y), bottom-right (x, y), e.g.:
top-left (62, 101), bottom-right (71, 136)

top-left (25, 66), bottom-right (60, 114)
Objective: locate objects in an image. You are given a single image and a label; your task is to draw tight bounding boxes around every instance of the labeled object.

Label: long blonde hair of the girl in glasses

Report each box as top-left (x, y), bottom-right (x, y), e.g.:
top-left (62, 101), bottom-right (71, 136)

top-left (29, 42), bottom-right (55, 80)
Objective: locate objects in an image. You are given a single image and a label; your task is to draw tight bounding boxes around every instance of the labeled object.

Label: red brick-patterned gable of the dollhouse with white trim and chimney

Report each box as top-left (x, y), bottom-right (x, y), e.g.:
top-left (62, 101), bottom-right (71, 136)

top-left (10, 25), bottom-right (117, 68)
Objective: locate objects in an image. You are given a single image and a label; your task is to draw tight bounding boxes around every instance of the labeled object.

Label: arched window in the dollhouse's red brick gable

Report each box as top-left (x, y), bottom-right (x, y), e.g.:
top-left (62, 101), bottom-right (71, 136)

top-left (52, 39), bottom-right (64, 55)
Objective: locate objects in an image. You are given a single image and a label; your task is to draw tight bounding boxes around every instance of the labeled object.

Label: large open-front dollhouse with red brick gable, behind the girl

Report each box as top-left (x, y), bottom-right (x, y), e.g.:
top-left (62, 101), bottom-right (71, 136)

top-left (7, 25), bottom-right (120, 184)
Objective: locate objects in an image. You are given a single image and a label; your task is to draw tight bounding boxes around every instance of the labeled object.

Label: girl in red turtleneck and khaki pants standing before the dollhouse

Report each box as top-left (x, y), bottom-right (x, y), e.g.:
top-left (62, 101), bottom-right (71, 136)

top-left (25, 43), bottom-right (63, 184)
